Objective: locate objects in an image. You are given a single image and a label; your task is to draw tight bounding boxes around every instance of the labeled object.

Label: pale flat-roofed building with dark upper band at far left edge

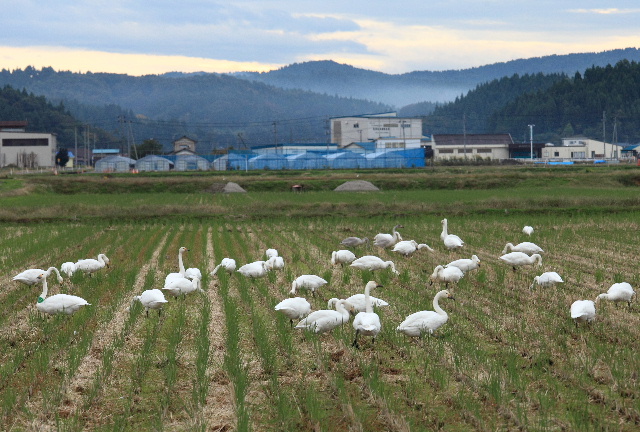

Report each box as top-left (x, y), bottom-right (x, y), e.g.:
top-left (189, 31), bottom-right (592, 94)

top-left (0, 121), bottom-right (58, 168)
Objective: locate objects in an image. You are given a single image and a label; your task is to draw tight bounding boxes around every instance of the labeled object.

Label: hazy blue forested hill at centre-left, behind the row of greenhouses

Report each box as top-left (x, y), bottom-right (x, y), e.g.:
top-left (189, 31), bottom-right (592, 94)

top-left (0, 67), bottom-right (390, 151)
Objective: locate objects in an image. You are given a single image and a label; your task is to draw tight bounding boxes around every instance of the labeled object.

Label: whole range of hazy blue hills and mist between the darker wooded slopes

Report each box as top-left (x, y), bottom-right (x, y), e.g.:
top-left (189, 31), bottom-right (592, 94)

top-left (0, 48), bottom-right (640, 149)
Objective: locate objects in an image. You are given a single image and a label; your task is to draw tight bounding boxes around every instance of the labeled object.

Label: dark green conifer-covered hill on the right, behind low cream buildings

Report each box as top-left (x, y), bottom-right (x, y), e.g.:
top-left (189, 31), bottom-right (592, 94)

top-left (487, 60), bottom-right (640, 143)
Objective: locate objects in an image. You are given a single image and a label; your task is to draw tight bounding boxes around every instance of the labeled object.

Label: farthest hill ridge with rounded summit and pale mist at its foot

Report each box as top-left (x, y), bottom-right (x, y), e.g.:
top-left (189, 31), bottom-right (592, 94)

top-left (235, 48), bottom-right (640, 106)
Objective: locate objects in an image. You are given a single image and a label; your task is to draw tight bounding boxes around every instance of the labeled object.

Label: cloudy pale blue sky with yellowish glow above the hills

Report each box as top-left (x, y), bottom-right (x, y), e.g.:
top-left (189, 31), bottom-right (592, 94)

top-left (0, 0), bottom-right (640, 75)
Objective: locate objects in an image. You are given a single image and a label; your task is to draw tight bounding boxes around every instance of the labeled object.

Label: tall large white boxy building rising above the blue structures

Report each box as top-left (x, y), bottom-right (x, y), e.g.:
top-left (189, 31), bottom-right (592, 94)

top-left (330, 112), bottom-right (422, 148)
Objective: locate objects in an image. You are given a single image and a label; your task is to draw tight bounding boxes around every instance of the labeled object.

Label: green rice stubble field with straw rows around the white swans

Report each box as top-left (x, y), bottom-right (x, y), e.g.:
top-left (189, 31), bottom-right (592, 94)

top-left (0, 167), bottom-right (640, 431)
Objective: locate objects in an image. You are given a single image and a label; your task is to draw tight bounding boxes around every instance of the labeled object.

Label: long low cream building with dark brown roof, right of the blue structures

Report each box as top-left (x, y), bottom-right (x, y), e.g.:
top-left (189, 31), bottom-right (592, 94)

top-left (432, 134), bottom-right (512, 159)
